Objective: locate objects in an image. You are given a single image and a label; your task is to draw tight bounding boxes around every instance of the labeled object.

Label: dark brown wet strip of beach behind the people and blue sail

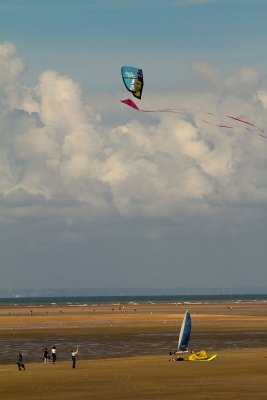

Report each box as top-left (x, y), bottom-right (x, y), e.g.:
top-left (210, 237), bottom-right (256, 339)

top-left (0, 332), bottom-right (267, 364)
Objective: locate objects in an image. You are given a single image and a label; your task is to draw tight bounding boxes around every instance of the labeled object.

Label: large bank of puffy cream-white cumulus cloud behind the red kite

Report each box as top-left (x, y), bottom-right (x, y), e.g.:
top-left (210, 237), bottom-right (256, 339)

top-left (0, 43), bottom-right (267, 225)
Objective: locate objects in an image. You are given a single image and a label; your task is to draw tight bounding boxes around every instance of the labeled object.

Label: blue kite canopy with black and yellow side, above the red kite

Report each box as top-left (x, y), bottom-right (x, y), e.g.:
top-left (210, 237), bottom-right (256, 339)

top-left (121, 67), bottom-right (144, 99)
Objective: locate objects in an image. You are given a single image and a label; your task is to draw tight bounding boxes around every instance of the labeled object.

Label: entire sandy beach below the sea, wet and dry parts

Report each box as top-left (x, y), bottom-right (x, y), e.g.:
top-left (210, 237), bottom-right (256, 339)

top-left (0, 302), bottom-right (267, 400)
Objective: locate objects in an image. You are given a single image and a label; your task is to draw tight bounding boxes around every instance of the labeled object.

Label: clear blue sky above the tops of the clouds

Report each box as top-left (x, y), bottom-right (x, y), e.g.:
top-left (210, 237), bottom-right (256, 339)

top-left (0, 0), bottom-right (267, 92)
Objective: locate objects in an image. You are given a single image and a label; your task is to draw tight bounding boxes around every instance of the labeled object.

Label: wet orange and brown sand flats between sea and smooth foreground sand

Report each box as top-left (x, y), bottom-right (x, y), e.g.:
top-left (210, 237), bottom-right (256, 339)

top-left (0, 302), bottom-right (267, 365)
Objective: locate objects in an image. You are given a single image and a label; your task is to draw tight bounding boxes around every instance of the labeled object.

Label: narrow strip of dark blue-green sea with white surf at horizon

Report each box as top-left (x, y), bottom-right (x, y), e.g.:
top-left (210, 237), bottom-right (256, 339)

top-left (0, 294), bottom-right (267, 307)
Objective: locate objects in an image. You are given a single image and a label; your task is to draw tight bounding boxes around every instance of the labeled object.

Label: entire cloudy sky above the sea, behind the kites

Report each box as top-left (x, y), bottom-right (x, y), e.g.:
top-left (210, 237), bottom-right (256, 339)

top-left (0, 0), bottom-right (267, 296)
